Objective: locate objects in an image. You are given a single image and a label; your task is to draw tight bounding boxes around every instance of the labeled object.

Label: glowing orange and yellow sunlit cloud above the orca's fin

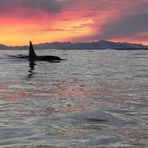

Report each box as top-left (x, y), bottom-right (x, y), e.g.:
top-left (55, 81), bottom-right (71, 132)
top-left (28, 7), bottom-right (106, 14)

top-left (0, 4), bottom-right (95, 45)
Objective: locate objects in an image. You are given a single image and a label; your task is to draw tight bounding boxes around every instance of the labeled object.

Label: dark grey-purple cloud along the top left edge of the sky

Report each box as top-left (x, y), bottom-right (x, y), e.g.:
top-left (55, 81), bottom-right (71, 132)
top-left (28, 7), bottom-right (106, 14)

top-left (0, 0), bottom-right (69, 13)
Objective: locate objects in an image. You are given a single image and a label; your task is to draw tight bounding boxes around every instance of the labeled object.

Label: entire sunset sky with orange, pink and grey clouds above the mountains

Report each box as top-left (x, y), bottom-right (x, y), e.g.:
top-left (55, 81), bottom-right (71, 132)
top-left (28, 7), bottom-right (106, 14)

top-left (0, 0), bottom-right (148, 46)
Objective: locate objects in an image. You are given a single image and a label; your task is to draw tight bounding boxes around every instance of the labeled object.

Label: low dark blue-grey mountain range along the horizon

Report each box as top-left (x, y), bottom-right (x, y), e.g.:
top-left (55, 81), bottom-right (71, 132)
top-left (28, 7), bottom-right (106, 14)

top-left (0, 40), bottom-right (148, 50)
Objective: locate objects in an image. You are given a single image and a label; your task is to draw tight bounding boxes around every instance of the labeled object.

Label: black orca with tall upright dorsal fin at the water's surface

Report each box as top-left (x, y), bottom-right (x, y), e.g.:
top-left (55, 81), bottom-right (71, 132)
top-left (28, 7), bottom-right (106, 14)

top-left (28, 41), bottom-right (62, 63)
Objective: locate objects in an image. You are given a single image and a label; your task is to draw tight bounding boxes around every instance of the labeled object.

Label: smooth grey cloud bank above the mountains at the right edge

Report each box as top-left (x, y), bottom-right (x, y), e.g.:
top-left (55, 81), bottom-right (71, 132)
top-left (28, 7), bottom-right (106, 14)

top-left (100, 13), bottom-right (148, 38)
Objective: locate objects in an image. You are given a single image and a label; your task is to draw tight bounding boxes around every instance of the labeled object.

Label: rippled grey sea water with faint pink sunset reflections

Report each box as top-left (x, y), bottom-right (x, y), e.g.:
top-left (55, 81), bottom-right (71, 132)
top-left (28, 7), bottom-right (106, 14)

top-left (0, 50), bottom-right (148, 148)
